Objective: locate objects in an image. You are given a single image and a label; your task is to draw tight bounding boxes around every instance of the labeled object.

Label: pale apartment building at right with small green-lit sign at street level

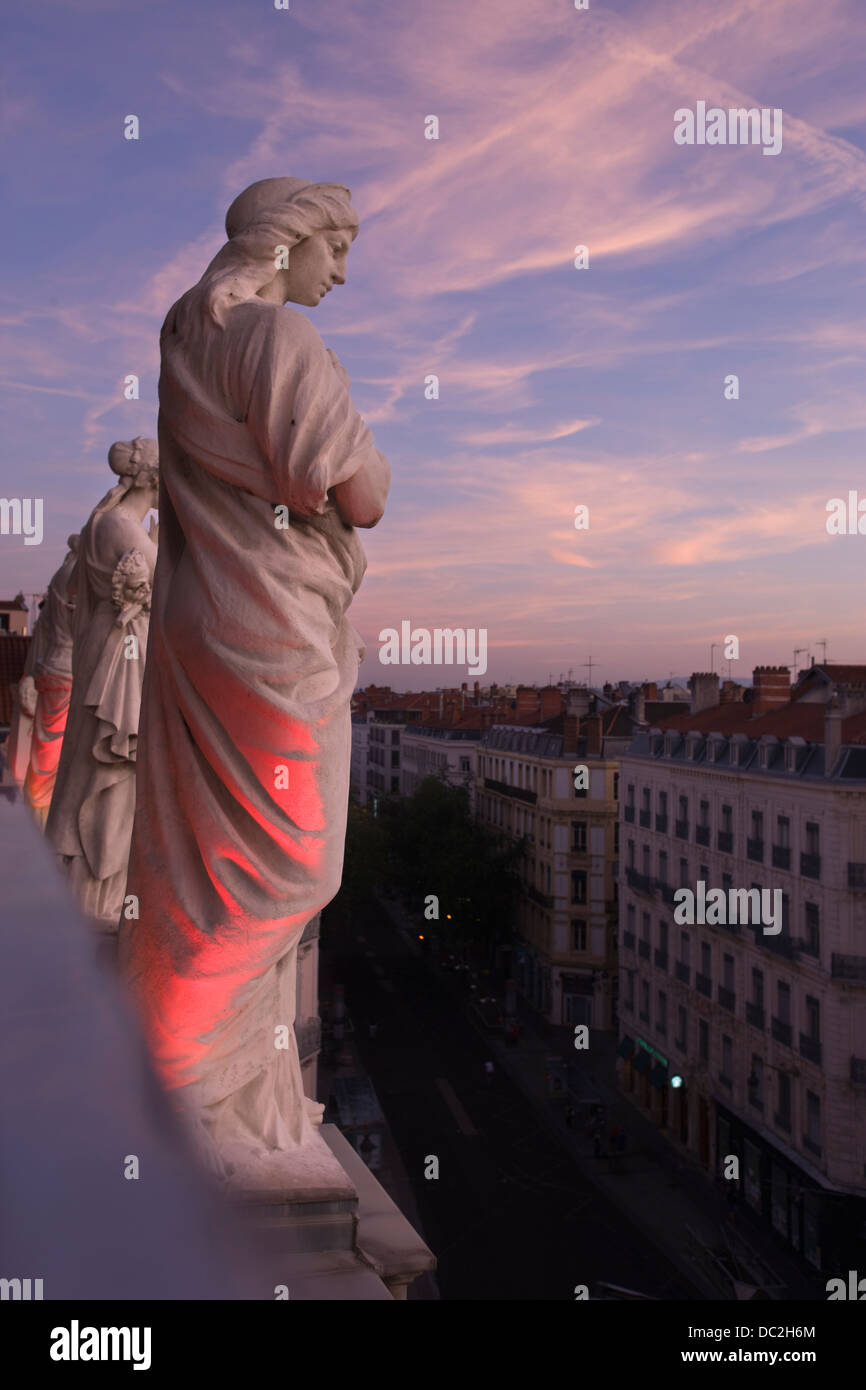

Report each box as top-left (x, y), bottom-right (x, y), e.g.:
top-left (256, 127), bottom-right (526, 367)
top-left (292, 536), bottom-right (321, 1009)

top-left (619, 669), bottom-right (866, 1269)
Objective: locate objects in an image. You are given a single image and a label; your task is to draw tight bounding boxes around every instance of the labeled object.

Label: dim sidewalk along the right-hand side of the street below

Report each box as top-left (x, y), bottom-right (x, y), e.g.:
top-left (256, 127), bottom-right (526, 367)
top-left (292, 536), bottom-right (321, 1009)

top-left (382, 901), bottom-right (826, 1301)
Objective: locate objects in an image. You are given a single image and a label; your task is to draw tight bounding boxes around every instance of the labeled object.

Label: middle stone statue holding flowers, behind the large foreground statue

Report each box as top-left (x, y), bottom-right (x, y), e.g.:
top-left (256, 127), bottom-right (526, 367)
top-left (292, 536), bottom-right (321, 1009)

top-left (46, 439), bottom-right (158, 933)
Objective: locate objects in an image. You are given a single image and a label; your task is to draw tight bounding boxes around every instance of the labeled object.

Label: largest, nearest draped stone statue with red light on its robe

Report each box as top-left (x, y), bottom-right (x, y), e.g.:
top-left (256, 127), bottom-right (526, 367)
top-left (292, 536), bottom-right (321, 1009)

top-left (120, 178), bottom-right (391, 1187)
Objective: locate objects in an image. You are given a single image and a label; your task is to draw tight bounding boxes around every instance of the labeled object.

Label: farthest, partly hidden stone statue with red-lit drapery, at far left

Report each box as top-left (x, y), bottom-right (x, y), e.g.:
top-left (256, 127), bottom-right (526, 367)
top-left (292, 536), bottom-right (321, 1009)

top-left (24, 535), bottom-right (79, 828)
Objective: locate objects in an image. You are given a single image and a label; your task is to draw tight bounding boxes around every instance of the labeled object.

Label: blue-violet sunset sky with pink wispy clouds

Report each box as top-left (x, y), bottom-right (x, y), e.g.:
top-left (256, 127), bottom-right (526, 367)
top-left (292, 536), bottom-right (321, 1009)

top-left (0, 0), bottom-right (866, 688)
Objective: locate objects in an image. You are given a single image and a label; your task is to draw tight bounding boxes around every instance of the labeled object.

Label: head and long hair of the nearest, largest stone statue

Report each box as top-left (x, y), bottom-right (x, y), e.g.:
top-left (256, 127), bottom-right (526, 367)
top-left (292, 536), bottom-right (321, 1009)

top-left (191, 178), bottom-right (359, 321)
